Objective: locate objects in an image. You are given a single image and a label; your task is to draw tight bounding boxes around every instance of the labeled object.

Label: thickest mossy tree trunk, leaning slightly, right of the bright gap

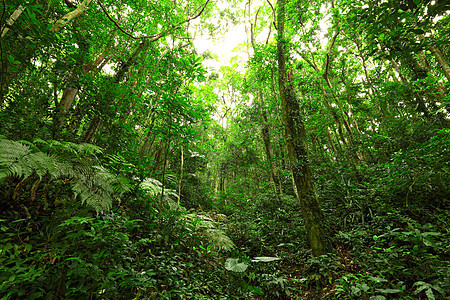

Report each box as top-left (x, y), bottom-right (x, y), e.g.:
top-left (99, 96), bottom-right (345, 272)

top-left (277, 0), bottom-right (331, 256)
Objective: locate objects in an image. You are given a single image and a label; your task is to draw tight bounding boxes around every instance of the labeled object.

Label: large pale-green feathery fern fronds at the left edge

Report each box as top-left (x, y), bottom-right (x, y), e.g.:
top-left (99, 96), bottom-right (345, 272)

top-left (0, 139), bottom-right (125, 212)
